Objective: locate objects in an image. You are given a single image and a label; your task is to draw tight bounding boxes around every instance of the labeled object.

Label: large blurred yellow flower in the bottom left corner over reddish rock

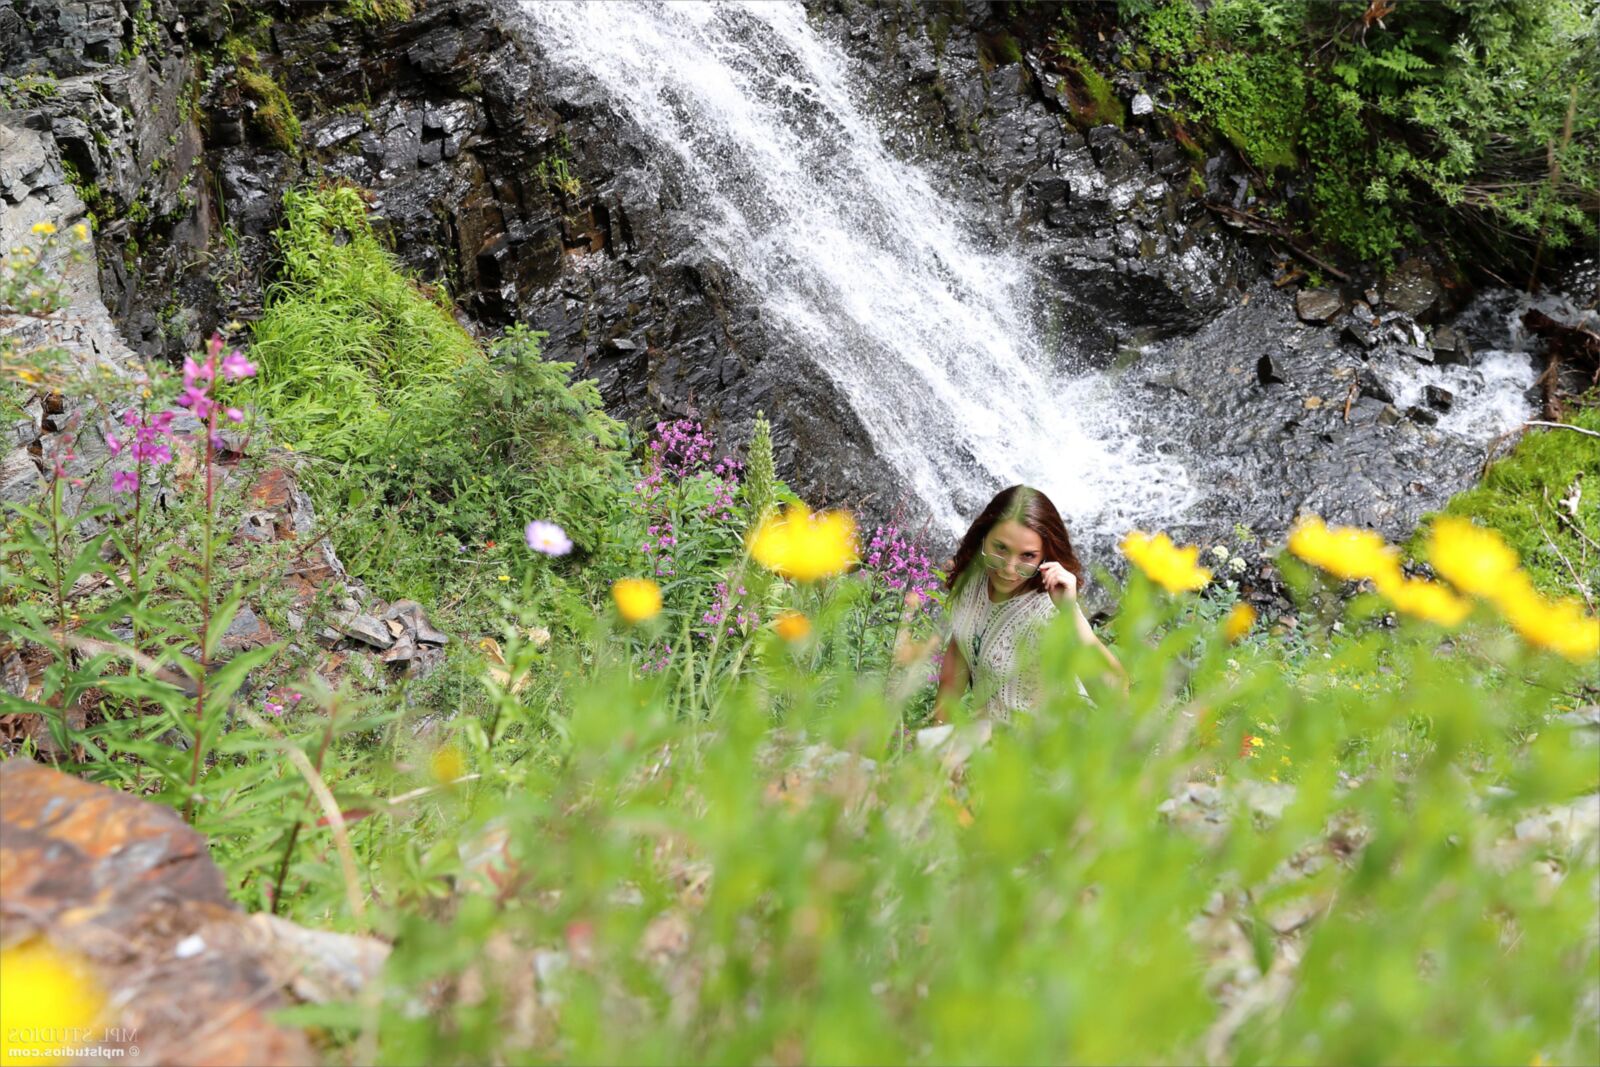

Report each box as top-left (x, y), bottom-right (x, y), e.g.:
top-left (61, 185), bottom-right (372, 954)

top-left (0, 937), bottom-right (106, 1064)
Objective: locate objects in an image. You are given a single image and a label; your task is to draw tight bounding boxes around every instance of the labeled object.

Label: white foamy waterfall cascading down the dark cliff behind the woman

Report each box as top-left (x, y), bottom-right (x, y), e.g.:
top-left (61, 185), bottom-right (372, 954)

top-left (505, 0), bottom-right (1194, 534)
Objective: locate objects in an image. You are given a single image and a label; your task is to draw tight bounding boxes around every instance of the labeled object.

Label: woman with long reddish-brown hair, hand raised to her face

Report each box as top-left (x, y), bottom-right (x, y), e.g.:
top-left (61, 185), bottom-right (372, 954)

top-left (934, 485), bottom-right (1123, 723)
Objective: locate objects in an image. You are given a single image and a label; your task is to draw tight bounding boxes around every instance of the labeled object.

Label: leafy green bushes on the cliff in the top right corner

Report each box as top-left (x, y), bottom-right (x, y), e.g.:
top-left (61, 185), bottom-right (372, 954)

top-left (1123, 0), bottom-right (1600, 266)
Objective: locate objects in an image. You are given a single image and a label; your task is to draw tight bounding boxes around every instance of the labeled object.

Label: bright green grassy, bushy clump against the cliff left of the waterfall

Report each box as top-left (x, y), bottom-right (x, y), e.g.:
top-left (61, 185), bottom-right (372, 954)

top-left (251, 187), bottom-right (624, 617)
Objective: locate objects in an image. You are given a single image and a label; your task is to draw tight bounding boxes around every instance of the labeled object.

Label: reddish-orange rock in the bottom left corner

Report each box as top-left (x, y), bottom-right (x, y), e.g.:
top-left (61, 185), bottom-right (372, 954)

top-left (0, 760), bottom-right (318, 1067)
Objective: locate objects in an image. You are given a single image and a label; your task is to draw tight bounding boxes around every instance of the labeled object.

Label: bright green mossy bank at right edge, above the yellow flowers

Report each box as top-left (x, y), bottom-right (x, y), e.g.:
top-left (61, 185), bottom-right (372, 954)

top-left (1408, 406), bottom-right (1600, 595)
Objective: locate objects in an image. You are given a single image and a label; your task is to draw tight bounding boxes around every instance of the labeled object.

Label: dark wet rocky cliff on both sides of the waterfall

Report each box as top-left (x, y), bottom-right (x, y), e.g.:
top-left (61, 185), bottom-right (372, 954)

top-left (0, 0), bottom-right (1574, 550)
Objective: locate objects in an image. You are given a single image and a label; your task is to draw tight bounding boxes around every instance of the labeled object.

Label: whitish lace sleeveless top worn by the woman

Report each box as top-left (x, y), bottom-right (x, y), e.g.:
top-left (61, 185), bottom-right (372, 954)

top-left (949, 568), bottom-right (1056, 721)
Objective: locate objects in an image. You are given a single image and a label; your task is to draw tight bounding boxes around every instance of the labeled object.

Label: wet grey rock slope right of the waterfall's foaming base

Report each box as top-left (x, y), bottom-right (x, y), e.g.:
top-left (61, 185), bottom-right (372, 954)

top-left (1123, 283), bottom-right (1483, 539)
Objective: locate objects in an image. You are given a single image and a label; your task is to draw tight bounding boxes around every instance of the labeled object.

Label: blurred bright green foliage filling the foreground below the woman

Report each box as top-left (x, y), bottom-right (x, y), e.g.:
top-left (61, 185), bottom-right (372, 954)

top-left (347, 563), bottom-right (1597, 1062)
